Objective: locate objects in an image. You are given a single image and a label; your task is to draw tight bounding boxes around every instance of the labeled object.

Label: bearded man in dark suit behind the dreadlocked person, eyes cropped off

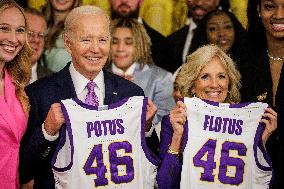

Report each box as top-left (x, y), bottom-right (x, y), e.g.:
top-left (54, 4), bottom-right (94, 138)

top-left (109, 0), bottom-right (171, 71)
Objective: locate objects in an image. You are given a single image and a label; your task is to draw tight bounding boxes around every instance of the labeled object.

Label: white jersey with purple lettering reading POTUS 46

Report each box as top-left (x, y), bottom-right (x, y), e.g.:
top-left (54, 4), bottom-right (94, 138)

top-left (52, 96), bottom-right (158, 189)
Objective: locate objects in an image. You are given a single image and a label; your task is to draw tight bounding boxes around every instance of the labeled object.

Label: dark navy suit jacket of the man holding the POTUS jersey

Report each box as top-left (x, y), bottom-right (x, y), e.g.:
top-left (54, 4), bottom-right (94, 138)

top-left (19, 63), bottom-right (144, 189)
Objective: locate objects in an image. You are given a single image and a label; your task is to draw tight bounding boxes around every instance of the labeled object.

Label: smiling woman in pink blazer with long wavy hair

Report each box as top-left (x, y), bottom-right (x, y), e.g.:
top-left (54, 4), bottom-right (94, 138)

top-left (0, 0), bottom-right (31, 189)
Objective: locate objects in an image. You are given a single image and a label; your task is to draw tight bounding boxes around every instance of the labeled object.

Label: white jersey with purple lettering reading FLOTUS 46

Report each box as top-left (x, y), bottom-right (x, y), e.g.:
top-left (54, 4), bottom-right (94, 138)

top-left (180, 98), bottom-right (272, 189)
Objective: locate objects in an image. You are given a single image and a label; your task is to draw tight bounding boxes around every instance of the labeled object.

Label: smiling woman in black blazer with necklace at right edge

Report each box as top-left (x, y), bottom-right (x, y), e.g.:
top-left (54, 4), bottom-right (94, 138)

top-left (242, 0), bottom-right (284, 188)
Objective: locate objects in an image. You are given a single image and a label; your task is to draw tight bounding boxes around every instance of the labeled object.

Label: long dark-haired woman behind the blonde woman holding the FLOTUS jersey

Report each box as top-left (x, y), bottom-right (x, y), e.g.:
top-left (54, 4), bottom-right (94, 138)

top-left (189, 9), bottom-right (247, 69)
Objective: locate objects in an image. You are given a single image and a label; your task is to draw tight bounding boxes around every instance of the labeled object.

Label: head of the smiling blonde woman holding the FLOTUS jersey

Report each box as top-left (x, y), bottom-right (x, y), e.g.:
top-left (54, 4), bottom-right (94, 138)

top-left (176, 45), bottom-right (241, 103)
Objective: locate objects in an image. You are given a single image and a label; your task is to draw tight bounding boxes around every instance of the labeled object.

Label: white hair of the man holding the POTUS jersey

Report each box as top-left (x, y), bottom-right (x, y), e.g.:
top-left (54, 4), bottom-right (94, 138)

top-left (64, 5), bottom-right (110, 36)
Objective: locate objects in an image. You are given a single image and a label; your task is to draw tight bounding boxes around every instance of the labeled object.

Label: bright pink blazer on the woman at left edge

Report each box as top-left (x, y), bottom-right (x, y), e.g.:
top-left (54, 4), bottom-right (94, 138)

top-left (0, 70), bottom-right (27, 189)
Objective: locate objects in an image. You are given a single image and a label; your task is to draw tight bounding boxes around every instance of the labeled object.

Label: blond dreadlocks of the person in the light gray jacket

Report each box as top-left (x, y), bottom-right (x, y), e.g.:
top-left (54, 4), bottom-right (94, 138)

top-left (111, 18), bottom-right (153, 67)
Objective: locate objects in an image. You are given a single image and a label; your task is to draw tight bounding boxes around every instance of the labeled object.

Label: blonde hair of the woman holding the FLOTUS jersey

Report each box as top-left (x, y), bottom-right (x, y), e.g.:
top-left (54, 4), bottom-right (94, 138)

top-left (176, 45), bottom-right (241, 103)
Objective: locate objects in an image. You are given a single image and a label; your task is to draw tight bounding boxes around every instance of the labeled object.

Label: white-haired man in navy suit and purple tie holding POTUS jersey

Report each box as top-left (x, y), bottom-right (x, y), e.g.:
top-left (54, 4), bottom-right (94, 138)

top-left (19, 6), bottom-right (156, 189)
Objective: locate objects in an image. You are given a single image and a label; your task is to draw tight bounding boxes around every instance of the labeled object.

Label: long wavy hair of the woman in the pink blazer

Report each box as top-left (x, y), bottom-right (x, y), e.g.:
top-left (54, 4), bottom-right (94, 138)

top-left (0, 0), bottom-right (31, 115)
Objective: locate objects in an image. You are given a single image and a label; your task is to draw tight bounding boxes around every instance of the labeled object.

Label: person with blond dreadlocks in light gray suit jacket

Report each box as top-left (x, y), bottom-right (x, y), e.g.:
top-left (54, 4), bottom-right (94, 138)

top-left (109, 18), bottom-right (175, 152)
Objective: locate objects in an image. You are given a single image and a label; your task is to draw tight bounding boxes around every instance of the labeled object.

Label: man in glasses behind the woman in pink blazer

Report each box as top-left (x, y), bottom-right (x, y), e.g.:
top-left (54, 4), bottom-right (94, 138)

top-left (25, 8), bottom-right (52, 83)
